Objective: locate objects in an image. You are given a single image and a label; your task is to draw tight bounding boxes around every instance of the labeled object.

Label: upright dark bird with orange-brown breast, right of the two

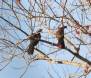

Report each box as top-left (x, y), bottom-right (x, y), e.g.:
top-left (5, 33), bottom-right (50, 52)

top-left (56, 26), bottom-right (67, 48)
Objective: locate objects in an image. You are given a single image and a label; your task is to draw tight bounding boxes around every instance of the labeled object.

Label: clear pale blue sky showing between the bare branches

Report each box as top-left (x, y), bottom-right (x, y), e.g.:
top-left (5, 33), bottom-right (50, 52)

top-left (0, 0), bottom-right (91, 78)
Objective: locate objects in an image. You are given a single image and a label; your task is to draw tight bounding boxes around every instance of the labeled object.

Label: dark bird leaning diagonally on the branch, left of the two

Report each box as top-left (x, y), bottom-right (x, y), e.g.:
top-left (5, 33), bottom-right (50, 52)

top-left (27, 29), bottom-right (42, 55)
